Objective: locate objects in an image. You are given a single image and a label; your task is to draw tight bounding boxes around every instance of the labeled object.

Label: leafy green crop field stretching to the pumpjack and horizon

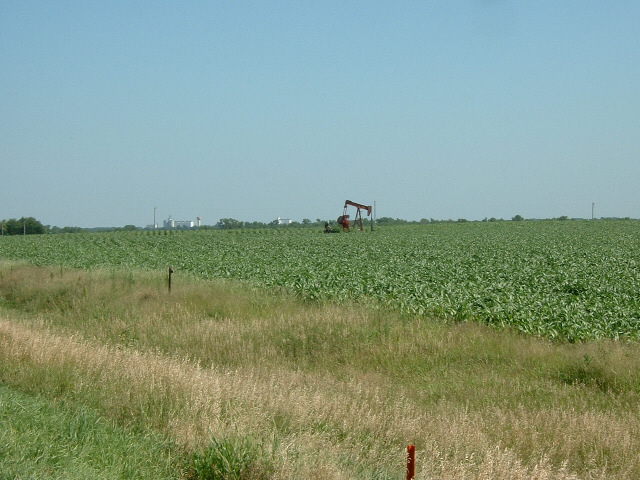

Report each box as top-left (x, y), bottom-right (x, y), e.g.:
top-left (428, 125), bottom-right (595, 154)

top-left (0, 220), bottom-right (640, 341)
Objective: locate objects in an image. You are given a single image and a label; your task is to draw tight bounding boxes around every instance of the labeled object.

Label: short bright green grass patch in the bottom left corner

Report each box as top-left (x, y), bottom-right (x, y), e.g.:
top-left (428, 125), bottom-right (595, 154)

top-left (0, 384), bottom-right (180, 480)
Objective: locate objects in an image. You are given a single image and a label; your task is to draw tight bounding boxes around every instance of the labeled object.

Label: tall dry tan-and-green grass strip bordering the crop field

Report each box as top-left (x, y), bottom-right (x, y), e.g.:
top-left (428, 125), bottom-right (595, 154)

top-left (0, 264), bottom-right (640, 479)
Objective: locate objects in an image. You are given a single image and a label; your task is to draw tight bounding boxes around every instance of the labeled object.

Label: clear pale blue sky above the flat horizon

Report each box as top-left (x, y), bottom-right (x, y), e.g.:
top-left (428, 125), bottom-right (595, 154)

top-left (0, 0), bottom-right (640, 227)
